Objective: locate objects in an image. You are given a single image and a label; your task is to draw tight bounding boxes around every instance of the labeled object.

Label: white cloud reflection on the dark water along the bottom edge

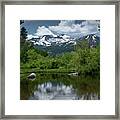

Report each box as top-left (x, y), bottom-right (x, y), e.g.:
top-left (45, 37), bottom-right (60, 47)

top-left (29, 82), bottom-right (98, 100)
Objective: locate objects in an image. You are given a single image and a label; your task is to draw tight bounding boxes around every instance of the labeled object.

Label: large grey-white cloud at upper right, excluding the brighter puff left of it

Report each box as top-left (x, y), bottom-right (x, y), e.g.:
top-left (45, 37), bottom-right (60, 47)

top-left (49, 20), bottom-right (99, 37)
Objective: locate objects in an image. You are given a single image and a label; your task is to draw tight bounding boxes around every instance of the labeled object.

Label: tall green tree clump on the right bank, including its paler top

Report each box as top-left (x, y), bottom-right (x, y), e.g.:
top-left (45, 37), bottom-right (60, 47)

top-left (76, 40), bottom-right (100, 74)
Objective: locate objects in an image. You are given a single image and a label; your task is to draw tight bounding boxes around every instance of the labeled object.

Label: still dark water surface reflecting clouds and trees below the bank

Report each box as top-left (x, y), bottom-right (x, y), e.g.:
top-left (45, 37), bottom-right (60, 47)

top-left (20, 73), bottom-right (100, 100)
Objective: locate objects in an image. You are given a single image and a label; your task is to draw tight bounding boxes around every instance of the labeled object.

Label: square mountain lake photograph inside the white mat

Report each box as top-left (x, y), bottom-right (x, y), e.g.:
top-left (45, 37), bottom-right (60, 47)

top-left (19, 20), bottom-right (100, 100)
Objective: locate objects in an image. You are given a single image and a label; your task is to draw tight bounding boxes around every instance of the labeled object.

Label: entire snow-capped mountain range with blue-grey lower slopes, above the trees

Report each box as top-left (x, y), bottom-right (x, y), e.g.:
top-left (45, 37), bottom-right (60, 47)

top-left (28, 34), bottom-right (100, 55)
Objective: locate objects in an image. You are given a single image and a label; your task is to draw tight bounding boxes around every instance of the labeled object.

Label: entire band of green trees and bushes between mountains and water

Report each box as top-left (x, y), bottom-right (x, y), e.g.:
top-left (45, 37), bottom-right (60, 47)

top-left (21, 37), bottom-right (100, 74)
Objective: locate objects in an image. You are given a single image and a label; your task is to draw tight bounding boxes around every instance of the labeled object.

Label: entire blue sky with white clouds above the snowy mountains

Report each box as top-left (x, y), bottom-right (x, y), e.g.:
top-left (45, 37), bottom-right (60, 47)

top-left (21, 20), bottom-right (100, 38)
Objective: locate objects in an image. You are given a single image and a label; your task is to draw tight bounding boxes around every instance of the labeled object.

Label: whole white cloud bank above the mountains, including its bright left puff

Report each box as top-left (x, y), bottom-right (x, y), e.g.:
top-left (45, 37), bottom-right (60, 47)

top-left (32, 20), bottom-right (100, 37)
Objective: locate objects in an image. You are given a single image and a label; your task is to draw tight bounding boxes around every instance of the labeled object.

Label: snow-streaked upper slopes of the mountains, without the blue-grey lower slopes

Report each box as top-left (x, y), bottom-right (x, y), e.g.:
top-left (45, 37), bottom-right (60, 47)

top-left (29, 30), bottom-right (99, 50)
